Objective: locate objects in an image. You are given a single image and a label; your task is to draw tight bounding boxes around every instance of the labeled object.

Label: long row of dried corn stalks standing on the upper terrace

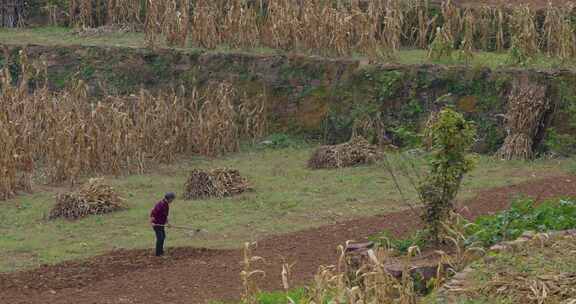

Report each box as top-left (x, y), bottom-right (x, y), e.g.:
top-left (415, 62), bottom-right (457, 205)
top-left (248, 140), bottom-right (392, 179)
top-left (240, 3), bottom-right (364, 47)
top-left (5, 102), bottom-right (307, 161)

top-left (54, 0), bottom-right (576, 62)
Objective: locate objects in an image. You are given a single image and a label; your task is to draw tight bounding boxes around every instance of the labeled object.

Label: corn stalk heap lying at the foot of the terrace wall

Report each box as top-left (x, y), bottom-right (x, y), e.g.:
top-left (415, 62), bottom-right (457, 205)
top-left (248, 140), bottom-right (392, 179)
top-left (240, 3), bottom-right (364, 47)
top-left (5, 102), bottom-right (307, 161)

top-left (308, 136), bottom-right (381, 169)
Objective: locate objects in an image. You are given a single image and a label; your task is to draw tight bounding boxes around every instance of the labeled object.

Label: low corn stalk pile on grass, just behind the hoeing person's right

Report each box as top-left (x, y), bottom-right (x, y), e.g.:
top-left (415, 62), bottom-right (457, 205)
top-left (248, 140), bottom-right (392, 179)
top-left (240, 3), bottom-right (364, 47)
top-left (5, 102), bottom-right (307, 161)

top-left (184, 168), bottom-right (249, 200)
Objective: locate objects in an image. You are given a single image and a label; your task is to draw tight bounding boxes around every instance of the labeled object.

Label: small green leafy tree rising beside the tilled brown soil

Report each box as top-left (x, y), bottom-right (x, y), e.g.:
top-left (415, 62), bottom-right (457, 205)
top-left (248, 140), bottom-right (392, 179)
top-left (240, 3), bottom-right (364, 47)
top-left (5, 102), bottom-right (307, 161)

top-left (418, 108), bottom-right (476, 242)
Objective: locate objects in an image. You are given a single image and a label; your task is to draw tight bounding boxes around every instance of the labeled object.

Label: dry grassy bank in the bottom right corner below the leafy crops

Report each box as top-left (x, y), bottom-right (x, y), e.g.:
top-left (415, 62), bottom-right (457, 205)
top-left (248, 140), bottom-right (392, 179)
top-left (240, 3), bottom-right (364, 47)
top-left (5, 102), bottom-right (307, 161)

top-left (423, 238), bottom-right (576, 304)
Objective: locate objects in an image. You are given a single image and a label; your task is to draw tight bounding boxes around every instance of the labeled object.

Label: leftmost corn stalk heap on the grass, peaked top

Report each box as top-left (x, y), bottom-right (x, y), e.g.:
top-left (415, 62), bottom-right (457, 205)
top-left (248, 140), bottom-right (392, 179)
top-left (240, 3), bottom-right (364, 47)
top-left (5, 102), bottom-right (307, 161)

top-left (50, 178), bottom-right (124, 219)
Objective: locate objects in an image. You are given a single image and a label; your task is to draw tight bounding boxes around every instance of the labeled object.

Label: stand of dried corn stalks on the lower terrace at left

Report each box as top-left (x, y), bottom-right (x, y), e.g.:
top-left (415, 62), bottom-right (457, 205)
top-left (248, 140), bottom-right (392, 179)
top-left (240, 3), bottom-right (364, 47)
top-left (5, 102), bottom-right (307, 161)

top-left (0, 51), bottom-right (266, 199)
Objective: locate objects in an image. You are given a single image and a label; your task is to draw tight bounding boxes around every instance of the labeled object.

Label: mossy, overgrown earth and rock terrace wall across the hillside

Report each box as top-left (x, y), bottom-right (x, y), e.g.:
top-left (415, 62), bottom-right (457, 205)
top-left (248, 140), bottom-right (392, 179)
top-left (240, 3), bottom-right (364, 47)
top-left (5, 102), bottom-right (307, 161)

top-left (0, 45), bottom-right (576, 153)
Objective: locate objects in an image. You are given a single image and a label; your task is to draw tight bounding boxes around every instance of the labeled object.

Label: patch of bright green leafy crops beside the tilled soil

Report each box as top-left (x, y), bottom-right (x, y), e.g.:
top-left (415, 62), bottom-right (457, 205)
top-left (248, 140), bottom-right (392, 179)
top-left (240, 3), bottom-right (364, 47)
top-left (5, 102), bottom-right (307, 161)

top-left (467, 199), bottom-right (576, 246)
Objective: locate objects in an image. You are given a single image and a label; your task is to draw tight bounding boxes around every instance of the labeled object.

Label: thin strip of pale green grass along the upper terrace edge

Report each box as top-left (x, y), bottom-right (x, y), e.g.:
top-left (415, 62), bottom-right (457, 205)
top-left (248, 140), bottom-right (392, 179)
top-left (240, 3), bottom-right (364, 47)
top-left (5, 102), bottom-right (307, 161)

top-left (0, 27), bottom-right (574, 68)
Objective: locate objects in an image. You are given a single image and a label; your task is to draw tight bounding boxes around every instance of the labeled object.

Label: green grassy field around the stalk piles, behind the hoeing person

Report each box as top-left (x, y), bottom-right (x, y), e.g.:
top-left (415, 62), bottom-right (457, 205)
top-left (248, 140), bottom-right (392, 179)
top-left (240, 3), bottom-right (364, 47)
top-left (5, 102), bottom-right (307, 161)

top-left (0, 148), bottom-right (567, 271)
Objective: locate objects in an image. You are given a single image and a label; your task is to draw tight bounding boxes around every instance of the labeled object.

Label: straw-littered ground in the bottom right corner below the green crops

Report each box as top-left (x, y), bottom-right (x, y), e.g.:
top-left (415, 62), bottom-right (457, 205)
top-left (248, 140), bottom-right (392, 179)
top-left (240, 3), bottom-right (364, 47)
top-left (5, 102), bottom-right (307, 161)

top-left (448, 235), bottom-right (576, 304)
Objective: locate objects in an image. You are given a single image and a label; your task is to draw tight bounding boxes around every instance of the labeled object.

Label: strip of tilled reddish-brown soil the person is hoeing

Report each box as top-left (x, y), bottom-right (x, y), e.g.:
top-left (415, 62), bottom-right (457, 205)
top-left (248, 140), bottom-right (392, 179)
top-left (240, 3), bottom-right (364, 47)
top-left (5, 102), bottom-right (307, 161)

top-left (0, 176), bottom-right (576, 304)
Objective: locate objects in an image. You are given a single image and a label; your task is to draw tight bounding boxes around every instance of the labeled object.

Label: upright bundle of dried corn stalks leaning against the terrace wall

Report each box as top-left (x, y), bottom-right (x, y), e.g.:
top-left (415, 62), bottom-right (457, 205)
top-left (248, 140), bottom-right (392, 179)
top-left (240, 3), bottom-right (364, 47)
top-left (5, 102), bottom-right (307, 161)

top-left (496, 81), bottom-right (551, 160)
